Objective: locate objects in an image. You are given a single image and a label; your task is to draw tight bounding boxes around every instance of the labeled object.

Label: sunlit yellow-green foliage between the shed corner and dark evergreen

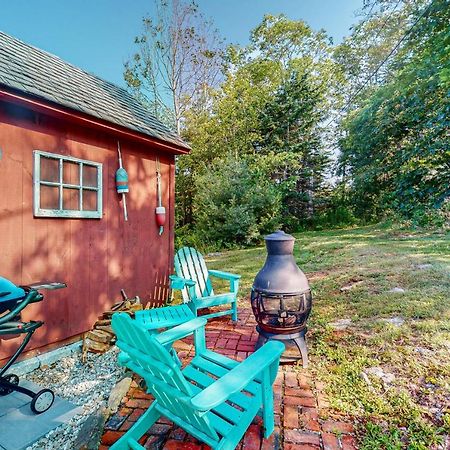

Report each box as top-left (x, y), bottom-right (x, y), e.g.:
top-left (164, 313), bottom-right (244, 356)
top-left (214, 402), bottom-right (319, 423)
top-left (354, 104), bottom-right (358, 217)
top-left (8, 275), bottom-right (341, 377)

top-left (176, 48), bottom-right (277, 232)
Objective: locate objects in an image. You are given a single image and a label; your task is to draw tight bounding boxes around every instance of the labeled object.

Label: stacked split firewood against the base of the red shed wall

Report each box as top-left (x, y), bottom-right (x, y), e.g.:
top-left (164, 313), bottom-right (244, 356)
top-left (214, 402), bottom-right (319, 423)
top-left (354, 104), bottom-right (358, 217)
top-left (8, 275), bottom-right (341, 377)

top-left (82, 289), bottom-right (143, 361)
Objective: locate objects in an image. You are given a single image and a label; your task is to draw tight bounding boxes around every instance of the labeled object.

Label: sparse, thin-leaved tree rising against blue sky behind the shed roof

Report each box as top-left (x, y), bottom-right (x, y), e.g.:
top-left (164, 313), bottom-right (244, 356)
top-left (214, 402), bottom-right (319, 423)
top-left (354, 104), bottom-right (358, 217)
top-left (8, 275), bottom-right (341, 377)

top-left (124, 0), bottom-right (223, 134)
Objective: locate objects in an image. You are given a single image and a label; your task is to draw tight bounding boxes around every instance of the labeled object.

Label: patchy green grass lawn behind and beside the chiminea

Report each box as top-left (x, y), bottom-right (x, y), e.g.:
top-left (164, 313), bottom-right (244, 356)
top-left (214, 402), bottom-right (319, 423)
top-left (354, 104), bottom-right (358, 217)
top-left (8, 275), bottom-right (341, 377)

top-left (208, 226), bottom-right (450, 449)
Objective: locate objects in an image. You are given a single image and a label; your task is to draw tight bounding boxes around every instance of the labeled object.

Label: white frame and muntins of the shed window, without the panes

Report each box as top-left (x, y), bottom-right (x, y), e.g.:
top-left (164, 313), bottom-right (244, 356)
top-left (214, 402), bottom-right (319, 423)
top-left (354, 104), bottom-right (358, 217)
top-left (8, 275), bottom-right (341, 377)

top-left (33, 150), bottom-right (103, 219)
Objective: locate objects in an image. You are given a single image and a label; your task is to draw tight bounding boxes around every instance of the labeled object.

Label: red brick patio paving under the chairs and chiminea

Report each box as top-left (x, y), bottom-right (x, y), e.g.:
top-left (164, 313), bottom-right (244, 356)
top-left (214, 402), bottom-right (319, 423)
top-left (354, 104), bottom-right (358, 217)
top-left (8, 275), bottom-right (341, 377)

top-left (100, 309), bottom-right (357, 450)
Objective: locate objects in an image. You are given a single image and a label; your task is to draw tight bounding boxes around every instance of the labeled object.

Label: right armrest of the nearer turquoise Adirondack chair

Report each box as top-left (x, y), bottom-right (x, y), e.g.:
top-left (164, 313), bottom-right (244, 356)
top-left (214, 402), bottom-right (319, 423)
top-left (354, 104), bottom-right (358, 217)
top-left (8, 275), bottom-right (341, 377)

top-left (191, 341), bottom-right (285, 411)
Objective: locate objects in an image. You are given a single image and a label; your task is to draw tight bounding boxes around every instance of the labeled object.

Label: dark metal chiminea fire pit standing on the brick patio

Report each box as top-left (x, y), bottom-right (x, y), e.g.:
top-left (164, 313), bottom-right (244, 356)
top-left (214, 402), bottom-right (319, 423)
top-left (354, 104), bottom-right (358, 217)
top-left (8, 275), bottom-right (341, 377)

top-left (251, 230), bottom-right (312, 368)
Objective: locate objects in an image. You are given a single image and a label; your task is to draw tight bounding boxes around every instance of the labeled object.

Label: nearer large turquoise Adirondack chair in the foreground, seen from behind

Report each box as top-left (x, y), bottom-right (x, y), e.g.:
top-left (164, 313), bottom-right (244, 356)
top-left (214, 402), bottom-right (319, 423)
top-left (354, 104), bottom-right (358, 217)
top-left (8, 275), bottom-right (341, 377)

top-left (111, 313), bottom-right (284, 450)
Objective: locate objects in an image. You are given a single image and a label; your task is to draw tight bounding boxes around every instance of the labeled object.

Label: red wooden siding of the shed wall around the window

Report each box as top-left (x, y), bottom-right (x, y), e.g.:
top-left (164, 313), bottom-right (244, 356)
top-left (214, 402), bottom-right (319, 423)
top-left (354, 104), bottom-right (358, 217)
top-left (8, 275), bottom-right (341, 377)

top-left (0, 100), bottom-right (174, 359)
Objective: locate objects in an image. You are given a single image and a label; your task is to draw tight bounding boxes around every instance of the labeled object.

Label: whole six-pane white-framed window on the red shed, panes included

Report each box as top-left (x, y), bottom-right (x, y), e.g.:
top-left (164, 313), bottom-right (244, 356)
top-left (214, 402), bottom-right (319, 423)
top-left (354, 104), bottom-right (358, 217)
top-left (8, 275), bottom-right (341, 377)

top-left (33, 150), bottom-right (102, 219)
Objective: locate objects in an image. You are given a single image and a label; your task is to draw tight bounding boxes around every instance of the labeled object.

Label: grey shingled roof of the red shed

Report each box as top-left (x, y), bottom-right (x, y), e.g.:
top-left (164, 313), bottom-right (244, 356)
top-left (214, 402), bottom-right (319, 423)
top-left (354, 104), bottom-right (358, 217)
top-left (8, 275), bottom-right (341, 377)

top-left (0, 31), bottom-right (189, 150)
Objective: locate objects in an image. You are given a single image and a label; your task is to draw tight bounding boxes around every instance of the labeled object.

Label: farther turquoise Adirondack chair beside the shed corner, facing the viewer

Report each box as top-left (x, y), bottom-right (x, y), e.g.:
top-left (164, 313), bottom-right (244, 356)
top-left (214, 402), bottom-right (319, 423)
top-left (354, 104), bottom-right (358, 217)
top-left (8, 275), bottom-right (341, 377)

top-left (170, 247), bottom-right (241, 322)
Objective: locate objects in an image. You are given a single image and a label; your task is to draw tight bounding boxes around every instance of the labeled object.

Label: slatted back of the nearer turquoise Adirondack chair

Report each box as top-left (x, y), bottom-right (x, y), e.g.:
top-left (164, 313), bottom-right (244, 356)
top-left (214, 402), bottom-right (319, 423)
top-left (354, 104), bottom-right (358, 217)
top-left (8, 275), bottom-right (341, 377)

top-left (112, 313), bottom-right (218, 440)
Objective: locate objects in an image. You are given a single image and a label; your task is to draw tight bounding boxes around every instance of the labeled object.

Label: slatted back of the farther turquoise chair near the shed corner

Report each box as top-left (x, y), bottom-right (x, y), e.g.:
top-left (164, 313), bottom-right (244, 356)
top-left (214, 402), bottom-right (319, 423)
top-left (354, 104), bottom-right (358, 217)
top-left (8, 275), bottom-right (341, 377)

top-left (174, 247), bottom-right (214, 302)
